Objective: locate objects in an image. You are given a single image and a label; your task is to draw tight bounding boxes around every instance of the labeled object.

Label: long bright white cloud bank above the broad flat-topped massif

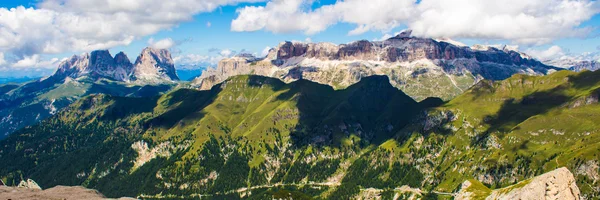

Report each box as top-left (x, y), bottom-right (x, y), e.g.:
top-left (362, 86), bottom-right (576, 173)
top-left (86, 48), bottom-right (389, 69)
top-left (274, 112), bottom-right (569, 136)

top-left (231, 0), bottom-right (600, 44)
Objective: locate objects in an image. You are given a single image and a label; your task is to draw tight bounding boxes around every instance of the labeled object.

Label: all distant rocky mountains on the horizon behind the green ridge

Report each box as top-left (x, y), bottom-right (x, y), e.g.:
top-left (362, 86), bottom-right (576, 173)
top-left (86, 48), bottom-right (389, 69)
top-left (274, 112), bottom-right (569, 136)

top-left (0, 31), bottom-right (559, 138)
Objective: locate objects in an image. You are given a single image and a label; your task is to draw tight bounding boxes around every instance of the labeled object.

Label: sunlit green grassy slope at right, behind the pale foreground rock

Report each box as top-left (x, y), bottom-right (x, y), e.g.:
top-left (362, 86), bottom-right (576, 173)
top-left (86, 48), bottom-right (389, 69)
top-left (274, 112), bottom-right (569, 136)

top-left (382, 71), bottom-right (600, 197)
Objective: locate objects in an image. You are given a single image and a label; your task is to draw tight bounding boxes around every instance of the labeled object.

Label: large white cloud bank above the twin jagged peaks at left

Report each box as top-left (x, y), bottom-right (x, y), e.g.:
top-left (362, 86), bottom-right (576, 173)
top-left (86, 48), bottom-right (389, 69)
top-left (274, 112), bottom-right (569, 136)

top-left (0, 0), bottom-right (264, 65)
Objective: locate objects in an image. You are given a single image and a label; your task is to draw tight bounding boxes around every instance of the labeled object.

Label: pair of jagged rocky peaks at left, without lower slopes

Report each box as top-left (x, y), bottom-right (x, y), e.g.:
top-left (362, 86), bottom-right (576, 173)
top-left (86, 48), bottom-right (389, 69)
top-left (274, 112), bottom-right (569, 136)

top-left (52, 48), bottom-right (179, 82)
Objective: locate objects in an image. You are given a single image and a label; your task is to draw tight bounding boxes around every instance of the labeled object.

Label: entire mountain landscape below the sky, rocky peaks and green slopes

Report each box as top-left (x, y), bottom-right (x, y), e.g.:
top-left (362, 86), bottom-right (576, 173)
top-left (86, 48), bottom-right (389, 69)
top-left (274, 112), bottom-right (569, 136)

top-left (0, 32), bottom-right (600, 199)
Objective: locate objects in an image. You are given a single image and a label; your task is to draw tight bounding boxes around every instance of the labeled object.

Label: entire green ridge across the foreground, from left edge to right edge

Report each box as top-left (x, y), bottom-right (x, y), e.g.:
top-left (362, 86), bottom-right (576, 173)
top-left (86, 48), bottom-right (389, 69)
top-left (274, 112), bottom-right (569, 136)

top-left (0, 71), bottom-right (600, 199)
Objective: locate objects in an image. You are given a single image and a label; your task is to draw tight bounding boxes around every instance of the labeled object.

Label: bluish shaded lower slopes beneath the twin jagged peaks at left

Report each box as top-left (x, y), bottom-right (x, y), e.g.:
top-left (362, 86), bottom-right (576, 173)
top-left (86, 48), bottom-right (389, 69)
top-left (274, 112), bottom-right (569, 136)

top-left (0, 77), bottom-right (175, 139)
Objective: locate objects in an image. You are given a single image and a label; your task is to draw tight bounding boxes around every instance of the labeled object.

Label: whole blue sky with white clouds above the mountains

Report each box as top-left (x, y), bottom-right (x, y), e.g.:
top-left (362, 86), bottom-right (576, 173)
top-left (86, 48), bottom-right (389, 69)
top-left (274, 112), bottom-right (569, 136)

top-left (0, 0), bottom-right (600, 77)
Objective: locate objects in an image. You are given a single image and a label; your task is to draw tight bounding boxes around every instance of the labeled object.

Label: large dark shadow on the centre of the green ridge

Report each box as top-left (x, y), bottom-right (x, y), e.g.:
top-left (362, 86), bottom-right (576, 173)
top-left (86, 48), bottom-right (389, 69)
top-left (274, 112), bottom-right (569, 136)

top-left (278, 76), bottom-right (421, 147)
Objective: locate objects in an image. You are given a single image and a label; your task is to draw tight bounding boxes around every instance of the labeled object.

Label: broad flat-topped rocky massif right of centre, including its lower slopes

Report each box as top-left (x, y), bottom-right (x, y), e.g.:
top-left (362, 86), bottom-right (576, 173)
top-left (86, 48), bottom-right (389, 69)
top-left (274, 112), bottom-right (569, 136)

top-left (194, 31), bottom-right (557, 100)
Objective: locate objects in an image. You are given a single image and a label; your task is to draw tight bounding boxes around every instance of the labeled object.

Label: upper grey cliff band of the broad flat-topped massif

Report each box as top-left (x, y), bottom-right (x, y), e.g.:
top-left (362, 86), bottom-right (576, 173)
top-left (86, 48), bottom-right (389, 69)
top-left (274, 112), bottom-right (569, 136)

top-left (270, 33), bottom-right (549, 71)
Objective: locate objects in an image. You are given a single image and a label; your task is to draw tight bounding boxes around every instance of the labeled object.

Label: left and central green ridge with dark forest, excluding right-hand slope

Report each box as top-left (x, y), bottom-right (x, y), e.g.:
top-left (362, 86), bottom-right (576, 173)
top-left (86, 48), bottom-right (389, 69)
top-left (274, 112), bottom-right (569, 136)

top-left (0, 76), bottom-right (432, 198)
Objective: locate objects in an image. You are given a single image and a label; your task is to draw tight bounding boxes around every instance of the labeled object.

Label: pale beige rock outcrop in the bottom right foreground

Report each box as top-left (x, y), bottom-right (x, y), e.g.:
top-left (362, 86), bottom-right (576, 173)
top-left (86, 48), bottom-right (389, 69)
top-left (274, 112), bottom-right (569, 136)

top-left (455, 167), bottom-right (581, 200)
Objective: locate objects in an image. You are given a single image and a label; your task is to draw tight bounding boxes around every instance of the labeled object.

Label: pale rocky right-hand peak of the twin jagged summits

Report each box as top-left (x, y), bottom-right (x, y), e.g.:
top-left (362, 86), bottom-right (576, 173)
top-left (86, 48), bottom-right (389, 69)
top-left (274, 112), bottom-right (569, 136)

top-left (131, 47), bottom-right (179, 81)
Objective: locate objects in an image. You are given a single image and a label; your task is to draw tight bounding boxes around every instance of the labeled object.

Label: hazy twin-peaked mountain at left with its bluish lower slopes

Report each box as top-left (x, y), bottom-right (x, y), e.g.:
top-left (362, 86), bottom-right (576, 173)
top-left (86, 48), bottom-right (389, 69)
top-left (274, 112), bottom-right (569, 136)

top-left (0, 48), bottom-right (179, 139)
